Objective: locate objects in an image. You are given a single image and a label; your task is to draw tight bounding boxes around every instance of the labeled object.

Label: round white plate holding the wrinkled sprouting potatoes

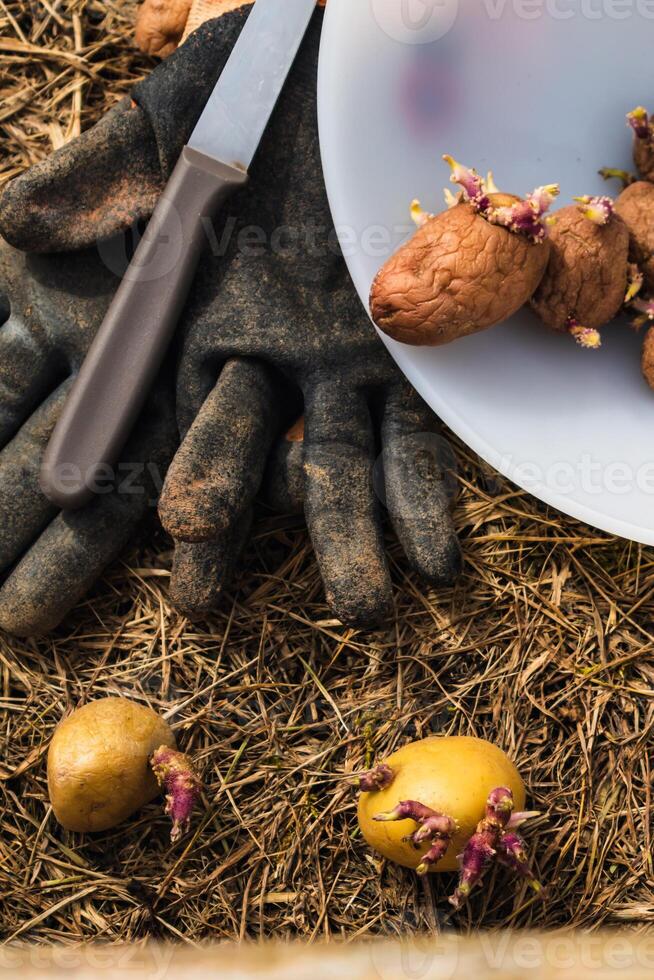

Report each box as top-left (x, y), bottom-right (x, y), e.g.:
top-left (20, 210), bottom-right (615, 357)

top-left (319, 0), bottom-right (654, 544)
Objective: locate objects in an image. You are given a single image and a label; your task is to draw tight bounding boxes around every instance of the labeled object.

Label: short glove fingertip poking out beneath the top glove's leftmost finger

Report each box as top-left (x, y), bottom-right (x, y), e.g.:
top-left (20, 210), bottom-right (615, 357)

top-left (169, 508), bottom-right (252, 619)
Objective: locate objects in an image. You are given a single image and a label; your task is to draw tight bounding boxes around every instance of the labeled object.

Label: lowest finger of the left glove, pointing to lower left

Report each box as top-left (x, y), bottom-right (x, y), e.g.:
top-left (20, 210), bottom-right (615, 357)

top-left (0, 382), bottom-right (175, 636)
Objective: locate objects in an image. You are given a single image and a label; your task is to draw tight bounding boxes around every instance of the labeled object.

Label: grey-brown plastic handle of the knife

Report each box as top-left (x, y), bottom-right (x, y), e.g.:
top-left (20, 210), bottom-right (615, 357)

top-left (41, 147), bottom-right (247, 510)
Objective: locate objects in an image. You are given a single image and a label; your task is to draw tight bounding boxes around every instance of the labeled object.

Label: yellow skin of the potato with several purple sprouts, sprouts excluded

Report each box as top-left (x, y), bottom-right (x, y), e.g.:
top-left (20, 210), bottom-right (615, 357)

top-left (358, 735), bottom-right (525, 871)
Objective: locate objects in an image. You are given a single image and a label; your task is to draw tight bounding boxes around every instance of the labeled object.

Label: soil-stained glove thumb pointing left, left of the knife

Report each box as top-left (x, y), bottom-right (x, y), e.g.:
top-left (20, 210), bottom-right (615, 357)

top-left (0, 99), bottom-right (163, 252)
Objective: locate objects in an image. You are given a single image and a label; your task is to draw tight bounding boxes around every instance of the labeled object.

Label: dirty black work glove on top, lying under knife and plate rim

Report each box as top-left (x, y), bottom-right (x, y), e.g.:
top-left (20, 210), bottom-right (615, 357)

top-left (0, 8), bottom-right (460, 625)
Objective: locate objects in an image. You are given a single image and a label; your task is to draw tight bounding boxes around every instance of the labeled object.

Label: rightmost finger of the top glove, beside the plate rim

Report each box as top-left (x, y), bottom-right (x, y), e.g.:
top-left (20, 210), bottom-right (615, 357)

top-left (382, 382), bottom-right (461, 585)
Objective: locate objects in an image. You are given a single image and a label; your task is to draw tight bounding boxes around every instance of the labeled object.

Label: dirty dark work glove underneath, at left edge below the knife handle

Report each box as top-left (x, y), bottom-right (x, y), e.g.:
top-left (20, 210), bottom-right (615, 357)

top-left (0, 242), bottom-right (176, 635)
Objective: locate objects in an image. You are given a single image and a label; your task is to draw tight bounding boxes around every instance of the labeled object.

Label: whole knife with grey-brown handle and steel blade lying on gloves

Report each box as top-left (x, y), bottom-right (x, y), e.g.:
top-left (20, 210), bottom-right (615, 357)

top-left (41, 0), bottom-right (316, 510)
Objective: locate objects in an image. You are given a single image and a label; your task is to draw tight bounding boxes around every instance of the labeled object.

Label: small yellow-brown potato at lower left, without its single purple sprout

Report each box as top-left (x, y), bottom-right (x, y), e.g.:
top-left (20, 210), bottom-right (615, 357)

top-left (48, 698), bottom-right (175, 833)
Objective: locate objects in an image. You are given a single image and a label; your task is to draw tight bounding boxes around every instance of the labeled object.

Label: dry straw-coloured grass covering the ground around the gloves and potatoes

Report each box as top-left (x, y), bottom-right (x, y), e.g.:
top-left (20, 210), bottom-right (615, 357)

top-left (0, 0), bottom-right (654, 944)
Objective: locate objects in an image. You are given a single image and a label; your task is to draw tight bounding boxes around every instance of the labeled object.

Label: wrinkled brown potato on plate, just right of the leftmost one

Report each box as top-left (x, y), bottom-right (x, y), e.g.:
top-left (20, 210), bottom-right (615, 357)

top-left (531, 205), bottom-right (636, 330)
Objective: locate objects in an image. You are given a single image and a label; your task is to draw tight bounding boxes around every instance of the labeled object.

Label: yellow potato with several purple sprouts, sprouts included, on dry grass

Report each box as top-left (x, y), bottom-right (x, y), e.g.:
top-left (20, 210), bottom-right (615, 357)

top-left (358, 736), bottom-right (540, 907)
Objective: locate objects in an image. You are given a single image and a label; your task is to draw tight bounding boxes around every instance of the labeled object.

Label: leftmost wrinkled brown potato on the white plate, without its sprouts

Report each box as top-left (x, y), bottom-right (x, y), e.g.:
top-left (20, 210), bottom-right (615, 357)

top-left (370, 194), bottom-right (549, 346)
